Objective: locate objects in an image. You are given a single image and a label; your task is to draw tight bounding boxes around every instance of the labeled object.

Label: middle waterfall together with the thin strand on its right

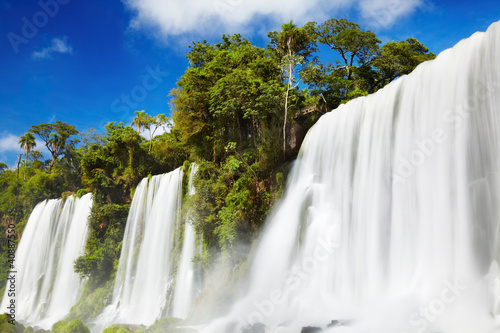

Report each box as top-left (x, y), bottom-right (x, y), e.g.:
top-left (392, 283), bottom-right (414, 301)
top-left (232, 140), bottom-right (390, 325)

top-left (98, 164), bottom-right (202, 331)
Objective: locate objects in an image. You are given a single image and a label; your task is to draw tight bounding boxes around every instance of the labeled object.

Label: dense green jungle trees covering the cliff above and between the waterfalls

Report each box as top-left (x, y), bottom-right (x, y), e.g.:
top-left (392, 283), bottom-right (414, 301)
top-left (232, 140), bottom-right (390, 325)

top-left (0, 19), bottom-right (435, 324)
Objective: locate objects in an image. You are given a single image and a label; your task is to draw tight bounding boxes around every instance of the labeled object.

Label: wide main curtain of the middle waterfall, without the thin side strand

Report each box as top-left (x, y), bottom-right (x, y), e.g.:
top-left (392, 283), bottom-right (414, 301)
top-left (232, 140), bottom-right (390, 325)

top-left (102, 168), bottom-right (182, 326)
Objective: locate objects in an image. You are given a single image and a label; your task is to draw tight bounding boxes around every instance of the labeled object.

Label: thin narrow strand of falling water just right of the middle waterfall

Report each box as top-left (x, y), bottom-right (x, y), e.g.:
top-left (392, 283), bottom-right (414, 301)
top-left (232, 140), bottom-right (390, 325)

top-left (172, 163), bottom-right (202, 319)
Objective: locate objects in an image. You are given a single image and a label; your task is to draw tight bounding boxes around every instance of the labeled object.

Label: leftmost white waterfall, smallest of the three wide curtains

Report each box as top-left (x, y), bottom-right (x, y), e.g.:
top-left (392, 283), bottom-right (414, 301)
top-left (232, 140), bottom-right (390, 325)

top-left (1, 194), bottom-right (92, 329)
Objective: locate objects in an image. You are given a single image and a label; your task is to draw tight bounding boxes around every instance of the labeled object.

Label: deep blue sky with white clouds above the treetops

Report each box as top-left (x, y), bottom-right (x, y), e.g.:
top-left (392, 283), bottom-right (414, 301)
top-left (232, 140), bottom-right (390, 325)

top-left (0, 0), bottom-right (500, 166)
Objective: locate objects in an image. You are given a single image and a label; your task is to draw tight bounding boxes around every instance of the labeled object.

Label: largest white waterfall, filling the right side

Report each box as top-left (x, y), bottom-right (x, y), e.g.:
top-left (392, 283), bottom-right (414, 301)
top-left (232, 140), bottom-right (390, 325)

top-left (203, 23), bottom-right (500, 333)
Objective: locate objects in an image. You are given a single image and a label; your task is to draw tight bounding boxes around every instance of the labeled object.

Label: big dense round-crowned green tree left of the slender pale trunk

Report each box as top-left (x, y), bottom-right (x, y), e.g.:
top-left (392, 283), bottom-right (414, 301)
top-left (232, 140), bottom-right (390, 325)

top-left (170, 34), bottom-right (283, 162)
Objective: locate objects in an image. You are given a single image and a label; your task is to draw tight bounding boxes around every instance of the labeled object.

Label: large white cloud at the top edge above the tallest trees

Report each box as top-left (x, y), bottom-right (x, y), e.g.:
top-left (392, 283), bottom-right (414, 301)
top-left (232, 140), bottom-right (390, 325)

top-left (123, 0), bottom-right (423, 35)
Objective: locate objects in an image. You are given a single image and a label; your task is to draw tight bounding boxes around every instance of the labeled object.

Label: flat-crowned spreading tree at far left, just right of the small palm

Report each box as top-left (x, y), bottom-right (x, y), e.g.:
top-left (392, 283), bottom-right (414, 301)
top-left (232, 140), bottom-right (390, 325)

top-left (29, 120), bottom-right (78, 168)
